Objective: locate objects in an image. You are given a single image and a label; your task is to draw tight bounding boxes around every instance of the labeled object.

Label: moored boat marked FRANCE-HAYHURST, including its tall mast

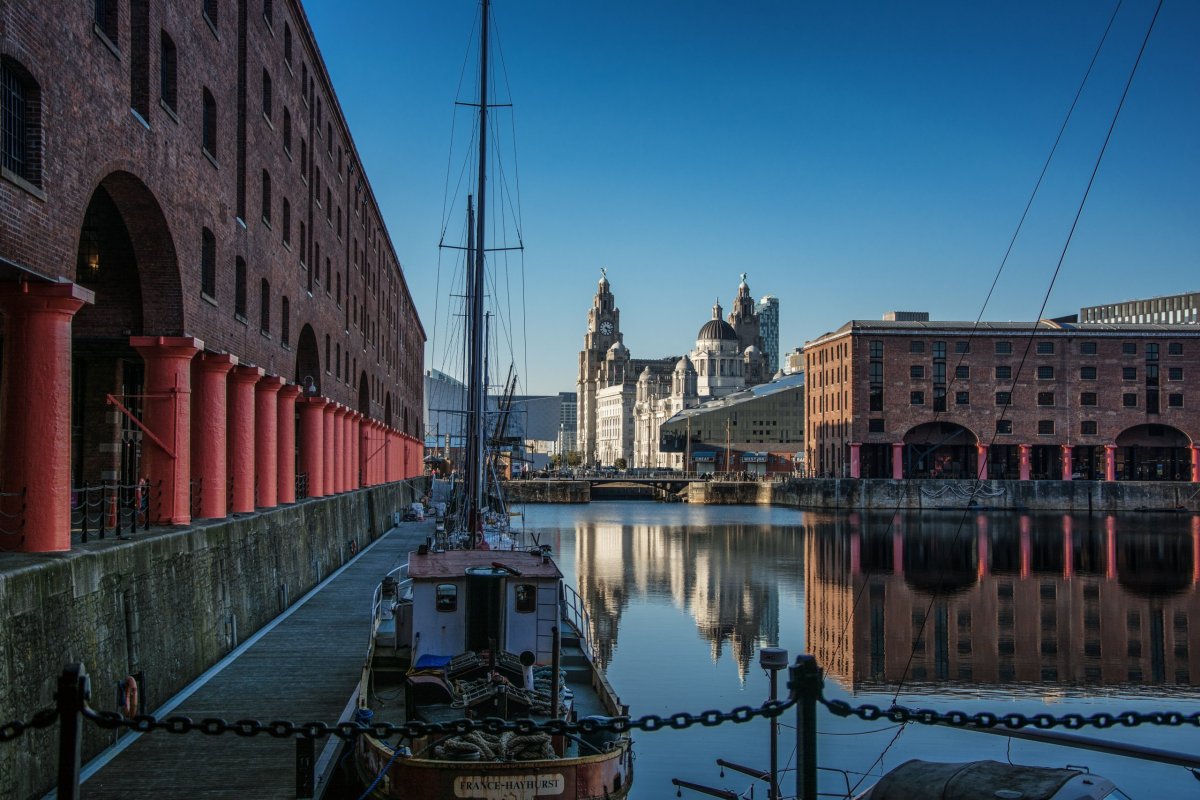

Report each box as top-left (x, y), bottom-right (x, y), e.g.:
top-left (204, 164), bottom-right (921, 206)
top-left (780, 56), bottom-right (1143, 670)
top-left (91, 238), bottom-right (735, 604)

top-left (354, 0), bottom-right (634, 800)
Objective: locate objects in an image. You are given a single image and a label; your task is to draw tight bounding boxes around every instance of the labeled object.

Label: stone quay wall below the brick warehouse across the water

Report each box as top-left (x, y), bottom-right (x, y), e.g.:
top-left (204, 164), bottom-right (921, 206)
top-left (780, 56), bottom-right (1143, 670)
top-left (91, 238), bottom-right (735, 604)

top-left (688, 479), bottom-right (1200, 513)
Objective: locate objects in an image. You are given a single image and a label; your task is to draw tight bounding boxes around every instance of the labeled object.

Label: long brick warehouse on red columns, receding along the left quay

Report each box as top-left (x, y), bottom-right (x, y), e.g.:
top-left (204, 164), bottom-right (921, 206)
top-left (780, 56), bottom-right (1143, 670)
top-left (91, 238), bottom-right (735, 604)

top-left (0, 0), bottom-right (425, 551)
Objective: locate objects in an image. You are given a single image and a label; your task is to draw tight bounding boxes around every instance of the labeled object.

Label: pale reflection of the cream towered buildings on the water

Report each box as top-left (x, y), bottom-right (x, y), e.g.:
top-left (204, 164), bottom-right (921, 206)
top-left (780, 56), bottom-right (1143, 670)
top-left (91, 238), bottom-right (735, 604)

top-left (575, 522), bottom-right (803, 679)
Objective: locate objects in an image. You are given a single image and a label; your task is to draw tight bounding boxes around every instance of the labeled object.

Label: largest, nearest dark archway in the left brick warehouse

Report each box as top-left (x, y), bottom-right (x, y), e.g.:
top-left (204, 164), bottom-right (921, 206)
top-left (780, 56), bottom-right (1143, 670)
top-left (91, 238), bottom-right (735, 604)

top-left (71, 172), bottom-right (185, 489)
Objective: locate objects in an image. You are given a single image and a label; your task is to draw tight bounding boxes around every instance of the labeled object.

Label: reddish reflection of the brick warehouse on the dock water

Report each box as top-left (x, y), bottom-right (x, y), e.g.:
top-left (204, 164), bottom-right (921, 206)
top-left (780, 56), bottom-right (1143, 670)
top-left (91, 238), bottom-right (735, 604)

top-left (804, 512), bottom-right (1200, 692)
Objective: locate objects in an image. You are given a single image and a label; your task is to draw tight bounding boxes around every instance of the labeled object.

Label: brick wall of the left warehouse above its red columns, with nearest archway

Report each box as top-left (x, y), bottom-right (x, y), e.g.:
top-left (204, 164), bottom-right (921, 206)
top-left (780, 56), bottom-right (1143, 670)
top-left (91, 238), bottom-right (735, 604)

top-left (0, 0), bottom-right (425, 551)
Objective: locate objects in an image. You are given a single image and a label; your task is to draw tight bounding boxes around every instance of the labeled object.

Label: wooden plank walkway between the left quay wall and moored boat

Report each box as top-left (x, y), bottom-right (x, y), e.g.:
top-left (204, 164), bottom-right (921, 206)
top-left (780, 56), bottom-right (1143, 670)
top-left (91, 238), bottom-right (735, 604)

top-left (80, 523), bottom-right (433, 800)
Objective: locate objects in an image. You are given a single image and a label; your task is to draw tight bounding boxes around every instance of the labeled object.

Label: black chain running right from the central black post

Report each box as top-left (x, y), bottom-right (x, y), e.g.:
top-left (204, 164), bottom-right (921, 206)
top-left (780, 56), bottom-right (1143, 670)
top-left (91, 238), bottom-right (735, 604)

top-left (820, 694), bottom-right (1200, 730)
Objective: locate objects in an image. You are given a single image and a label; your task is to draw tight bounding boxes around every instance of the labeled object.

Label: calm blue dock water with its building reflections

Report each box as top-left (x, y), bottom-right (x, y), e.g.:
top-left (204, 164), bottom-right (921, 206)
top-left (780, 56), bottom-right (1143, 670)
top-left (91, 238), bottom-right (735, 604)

top-left (526, 503), bottom-right (1200, 800)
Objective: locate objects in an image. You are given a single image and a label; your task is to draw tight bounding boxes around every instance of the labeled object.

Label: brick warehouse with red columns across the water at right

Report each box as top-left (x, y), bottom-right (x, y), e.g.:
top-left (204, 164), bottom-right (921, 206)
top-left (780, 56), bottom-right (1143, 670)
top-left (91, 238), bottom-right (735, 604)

top-left (804, 320), bottom-right (1200, 481)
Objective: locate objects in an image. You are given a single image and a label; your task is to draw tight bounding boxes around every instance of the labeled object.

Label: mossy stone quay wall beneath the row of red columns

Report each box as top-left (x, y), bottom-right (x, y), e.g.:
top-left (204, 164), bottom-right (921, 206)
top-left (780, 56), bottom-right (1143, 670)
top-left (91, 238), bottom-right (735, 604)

top-left (0, 483), bottom-right (416, 799)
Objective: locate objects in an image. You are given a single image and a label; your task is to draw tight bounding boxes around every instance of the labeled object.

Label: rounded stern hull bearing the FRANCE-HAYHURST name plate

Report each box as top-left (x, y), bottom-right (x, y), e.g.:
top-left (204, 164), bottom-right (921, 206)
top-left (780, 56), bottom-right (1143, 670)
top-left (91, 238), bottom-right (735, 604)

top-left (355, 738), bottom-right (634, 800)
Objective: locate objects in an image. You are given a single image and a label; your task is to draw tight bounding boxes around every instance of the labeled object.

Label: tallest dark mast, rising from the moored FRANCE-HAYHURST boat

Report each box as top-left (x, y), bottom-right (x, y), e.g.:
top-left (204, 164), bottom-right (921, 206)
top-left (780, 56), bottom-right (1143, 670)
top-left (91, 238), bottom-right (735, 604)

top-left (467, 0), bottom-right (488, 535)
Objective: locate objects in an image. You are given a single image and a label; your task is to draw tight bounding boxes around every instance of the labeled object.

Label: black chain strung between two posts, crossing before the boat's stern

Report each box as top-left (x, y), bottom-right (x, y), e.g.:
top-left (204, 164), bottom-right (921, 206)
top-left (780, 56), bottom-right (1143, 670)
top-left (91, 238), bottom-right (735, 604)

top-left (83, 700), bottom-right (796, 741)
